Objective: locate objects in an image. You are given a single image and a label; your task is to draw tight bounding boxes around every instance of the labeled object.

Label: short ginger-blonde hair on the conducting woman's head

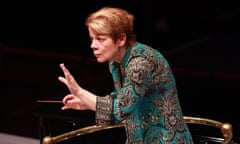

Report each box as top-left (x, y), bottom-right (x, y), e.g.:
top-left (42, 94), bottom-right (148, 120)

top-left (85, 7), bottom-right (136, 46)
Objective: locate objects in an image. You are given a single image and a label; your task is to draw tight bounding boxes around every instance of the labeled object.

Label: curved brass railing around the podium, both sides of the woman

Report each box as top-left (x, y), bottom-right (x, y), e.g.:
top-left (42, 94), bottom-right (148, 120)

top-left (43, 116), bottom-right (233, 144)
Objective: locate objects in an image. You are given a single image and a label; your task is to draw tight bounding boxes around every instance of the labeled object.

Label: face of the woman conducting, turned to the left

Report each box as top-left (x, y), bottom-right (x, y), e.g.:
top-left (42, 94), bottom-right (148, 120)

top-left (88, 28), bottom-right (125, 63)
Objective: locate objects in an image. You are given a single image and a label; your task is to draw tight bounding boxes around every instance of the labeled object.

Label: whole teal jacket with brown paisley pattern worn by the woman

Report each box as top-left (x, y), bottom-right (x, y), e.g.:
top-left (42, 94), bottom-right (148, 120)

top-left (96, 43), bottom-right (193, 144)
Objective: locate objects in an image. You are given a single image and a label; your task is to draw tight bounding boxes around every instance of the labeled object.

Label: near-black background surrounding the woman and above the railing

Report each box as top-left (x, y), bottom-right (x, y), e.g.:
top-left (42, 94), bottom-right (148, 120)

top-left (0, 0), bottom-right (240, 143)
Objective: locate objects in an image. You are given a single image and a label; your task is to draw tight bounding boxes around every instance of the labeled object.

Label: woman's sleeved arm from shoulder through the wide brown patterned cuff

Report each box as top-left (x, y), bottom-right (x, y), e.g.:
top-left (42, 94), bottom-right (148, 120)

top-left (96, 57), bottom-right (153, 125)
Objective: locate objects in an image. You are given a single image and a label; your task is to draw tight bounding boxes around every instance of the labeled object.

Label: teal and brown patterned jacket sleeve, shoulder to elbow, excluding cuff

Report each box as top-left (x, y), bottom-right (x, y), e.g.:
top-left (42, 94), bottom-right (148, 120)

top-left (113, 57), bottom-right (154, 121)
